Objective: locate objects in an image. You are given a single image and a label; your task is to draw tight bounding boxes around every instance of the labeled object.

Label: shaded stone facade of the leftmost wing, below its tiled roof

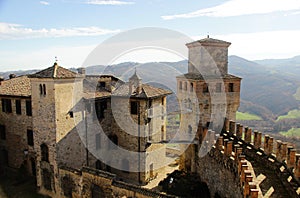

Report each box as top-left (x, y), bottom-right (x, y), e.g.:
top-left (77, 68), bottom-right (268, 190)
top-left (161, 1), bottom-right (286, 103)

top-left (0, 96), bottom-right (35, 175)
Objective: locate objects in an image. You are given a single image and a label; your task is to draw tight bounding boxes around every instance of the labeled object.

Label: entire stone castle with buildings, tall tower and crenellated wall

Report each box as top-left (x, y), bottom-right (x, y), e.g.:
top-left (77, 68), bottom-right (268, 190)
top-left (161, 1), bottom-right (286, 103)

top-left (0, 37), bottom-right (300, 197)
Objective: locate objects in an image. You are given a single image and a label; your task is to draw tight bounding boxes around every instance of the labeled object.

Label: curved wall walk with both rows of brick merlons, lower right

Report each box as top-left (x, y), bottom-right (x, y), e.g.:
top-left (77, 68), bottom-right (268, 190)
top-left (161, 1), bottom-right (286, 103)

top-left (196, 119), bottom-right (300, 197)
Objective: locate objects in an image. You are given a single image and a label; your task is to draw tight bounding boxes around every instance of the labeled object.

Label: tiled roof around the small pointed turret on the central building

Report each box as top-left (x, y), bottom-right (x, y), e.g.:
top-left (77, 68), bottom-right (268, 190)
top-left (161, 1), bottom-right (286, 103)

top-left (112, 83), bottom-right (172, 98)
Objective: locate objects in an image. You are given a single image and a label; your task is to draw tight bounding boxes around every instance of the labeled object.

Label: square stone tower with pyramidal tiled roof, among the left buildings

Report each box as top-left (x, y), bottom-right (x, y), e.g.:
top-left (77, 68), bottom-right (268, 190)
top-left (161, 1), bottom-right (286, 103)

top-left (30, 63), bottom-right (84, 196)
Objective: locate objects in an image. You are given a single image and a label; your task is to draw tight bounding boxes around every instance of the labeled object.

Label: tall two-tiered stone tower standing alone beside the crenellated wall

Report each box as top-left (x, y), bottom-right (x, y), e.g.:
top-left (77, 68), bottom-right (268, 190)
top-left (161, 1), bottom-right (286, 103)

top-left (177, 37), bottom-right (241, 171)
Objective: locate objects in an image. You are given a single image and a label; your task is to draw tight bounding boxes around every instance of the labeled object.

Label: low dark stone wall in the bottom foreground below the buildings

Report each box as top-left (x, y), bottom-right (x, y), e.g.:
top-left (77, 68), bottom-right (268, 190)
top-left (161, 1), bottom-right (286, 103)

top-left (57, 167), bottom-right (173, 198)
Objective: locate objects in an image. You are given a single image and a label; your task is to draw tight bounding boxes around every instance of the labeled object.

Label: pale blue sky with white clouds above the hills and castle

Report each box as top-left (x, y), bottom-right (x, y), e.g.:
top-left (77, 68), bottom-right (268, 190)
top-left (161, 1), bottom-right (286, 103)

top-left (0, 0), bottom-right (300, 71)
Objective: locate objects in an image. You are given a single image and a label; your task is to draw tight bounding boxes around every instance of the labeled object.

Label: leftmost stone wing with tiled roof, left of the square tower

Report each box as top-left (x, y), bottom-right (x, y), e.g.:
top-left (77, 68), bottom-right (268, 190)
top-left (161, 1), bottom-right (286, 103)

top-left (0, 75), bottom-right (36, 175)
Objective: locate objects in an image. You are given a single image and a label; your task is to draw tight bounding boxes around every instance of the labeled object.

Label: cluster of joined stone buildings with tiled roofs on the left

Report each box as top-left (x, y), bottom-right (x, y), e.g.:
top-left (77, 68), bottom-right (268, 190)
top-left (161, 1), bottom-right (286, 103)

top-left (0, 63), bottom-right (171, 197)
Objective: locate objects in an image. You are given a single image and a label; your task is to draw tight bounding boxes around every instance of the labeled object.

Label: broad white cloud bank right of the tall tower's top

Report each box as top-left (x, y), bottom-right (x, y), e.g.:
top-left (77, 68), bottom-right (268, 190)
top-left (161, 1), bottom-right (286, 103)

top-left (197, 30), bottom-right (300, 60)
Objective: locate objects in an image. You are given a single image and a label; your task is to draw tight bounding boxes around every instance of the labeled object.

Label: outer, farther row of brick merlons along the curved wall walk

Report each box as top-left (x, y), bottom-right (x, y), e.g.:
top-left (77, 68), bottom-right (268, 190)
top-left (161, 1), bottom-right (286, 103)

top-left (216, 120), bottom-right (300, 197)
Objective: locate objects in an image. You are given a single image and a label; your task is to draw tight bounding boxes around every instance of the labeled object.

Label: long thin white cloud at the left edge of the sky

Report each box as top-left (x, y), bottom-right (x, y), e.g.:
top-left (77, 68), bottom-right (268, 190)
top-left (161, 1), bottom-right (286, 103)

top-left (0, 23), bottom-right (120, 40)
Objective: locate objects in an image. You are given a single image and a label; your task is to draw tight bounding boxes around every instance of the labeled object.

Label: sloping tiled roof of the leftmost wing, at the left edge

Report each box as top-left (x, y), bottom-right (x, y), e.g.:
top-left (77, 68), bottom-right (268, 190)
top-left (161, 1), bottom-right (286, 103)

top-left (0, 76), bottom-right (31, 97)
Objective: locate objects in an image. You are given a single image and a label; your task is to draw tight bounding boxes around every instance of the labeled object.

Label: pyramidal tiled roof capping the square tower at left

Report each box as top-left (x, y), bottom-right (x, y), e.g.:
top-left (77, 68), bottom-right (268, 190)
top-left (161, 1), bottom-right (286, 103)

top-left (30, 63), bottom-right (78, 78)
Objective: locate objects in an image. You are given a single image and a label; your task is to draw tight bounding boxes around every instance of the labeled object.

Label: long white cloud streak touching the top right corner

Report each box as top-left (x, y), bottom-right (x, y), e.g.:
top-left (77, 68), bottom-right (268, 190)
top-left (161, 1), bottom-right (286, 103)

top-left (162, 0), bottom-right (300, 20)
